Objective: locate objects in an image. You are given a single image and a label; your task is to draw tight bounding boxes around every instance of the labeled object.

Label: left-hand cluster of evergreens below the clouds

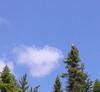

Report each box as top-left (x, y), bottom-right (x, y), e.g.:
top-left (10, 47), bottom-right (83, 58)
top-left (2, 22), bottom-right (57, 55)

top-left (0, 65), bottom-right (39, 92)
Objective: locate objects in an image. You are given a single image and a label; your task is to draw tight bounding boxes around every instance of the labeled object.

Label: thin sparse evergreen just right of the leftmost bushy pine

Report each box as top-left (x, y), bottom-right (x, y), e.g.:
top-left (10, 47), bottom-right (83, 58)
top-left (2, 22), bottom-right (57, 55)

top-left (19, 74), bottom-right (29, 92)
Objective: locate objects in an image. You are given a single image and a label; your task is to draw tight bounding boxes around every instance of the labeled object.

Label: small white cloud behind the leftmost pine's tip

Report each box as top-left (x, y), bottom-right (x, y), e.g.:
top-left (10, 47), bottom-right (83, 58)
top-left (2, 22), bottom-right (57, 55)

top-left (0, 58), bottom-right (14, 72)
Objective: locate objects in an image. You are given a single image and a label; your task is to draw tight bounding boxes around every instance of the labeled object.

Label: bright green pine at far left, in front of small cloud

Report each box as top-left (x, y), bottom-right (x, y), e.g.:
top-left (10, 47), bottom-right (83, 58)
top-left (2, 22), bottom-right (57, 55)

top-left (0, 65), bottom-right (19, 92)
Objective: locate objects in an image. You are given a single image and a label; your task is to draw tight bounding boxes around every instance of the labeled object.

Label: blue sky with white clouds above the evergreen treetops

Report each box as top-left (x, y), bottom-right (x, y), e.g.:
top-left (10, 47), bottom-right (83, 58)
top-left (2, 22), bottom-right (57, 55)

top-left (0, 0), bottom-right (100, 92)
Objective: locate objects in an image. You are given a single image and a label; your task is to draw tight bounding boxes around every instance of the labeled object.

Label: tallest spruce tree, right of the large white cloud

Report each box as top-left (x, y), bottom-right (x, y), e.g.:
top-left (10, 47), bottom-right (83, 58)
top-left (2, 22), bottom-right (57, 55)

top-left (62, 45), bottom-right (87, 92)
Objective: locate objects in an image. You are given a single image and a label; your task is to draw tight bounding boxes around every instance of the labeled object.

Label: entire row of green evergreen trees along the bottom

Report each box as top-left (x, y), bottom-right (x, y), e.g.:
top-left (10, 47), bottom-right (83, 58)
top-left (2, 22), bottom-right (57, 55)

top-left (0, 45), bottom-right (100, 92)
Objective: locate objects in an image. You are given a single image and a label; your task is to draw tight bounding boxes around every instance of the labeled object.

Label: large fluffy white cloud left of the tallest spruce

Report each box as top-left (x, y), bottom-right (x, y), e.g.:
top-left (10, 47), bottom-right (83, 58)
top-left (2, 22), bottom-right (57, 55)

top-left (14, 46), bottom-right (63, 77)
